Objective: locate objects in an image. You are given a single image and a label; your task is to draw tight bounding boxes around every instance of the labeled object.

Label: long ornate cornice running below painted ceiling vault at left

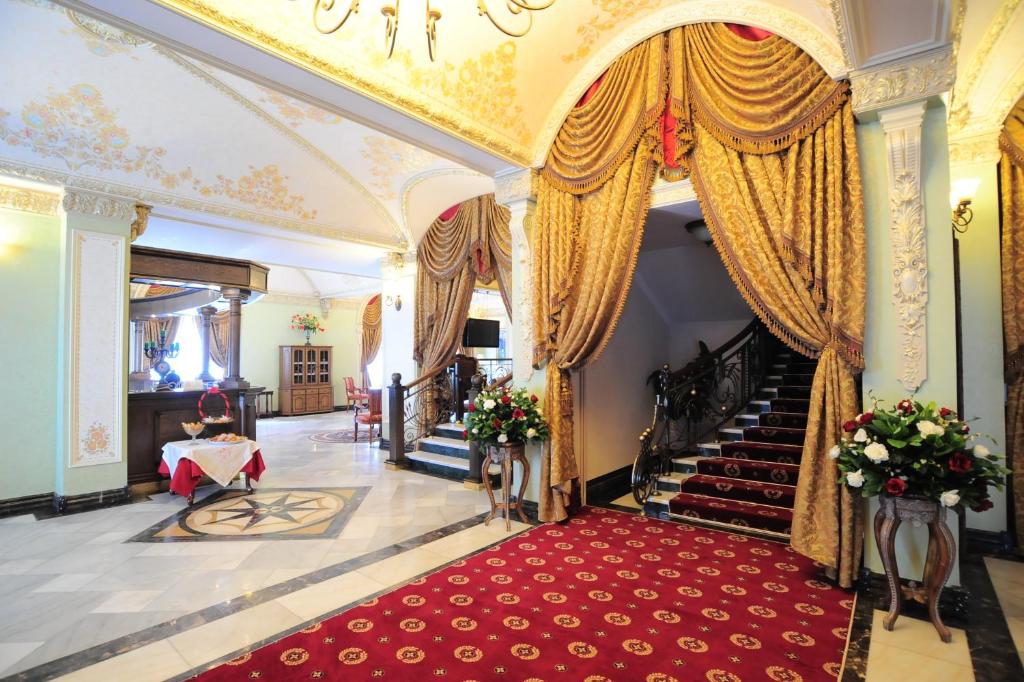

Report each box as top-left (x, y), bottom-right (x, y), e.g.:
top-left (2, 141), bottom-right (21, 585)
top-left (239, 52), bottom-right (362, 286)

top-left (0, 157), bottom-right (394, 250)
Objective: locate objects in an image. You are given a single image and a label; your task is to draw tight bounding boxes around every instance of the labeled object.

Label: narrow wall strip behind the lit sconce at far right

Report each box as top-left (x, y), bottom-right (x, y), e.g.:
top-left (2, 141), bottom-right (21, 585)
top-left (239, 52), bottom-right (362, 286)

top-left (950, 161), bottom-right (1007, 531)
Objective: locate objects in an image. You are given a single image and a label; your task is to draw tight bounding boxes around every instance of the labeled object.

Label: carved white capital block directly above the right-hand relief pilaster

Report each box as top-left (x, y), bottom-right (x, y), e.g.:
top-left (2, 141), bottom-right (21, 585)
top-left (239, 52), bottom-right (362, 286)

top-left (850, 45), bottom-right (956, 115)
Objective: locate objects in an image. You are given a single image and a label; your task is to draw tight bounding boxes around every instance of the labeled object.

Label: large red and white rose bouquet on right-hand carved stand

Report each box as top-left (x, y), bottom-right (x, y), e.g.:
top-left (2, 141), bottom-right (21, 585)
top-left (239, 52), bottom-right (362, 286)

top-left (828, 398), bottom-right (1010, 512)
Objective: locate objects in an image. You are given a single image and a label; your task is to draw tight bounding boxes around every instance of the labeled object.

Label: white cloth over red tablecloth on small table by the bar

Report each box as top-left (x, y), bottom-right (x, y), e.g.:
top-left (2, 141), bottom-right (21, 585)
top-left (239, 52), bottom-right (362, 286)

top-left (159, 439), bottom-right (266, 506)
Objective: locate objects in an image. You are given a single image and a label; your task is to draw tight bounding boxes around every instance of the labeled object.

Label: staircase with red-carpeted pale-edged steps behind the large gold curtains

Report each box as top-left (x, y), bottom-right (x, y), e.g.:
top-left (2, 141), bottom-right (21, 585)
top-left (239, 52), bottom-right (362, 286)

top-left (644, 352), bottom-right (817, 541)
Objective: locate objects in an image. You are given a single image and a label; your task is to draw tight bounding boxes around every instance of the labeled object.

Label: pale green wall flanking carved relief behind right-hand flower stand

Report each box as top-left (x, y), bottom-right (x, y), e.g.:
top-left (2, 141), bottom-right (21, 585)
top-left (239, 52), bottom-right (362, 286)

top-left (857, 106), bottom-right (959, 585)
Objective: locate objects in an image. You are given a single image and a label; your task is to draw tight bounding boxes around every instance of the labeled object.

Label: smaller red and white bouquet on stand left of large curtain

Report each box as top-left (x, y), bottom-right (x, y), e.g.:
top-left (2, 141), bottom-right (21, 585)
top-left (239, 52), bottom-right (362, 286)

top-left (462, 388), bottom-right (548, 445)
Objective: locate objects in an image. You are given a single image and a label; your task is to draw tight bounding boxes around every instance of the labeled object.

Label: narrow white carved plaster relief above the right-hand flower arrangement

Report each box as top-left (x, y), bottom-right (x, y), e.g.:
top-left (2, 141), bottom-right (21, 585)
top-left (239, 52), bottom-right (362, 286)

top-left (879, 101), bottom-right (928, 392)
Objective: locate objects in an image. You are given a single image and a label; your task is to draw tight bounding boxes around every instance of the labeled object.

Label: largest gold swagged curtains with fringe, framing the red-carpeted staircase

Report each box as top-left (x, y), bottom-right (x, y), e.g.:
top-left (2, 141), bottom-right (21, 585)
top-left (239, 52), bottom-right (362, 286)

top-left (534, 24), bottom-right (866, 586)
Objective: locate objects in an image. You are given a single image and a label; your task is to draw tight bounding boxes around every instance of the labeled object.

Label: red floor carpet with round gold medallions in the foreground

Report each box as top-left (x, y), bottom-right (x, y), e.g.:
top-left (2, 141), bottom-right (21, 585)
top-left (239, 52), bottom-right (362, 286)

top-left (198, 509), bottom-right (853, 682)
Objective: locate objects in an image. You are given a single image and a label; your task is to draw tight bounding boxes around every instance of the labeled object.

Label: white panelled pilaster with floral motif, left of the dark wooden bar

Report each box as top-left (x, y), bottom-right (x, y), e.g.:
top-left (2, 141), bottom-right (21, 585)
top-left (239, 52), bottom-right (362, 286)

top-left (54, 187), bottom-right (136, 501)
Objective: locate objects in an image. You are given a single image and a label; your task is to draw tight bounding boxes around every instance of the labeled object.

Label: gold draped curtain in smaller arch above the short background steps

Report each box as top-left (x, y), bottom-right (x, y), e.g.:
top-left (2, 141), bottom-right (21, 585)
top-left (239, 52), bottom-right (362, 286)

top-left (413, 195), bottom-right (512, 374)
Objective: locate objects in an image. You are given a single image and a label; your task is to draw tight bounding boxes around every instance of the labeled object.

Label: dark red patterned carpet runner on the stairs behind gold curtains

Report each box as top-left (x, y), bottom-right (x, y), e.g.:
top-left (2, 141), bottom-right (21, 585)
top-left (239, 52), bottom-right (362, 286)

top-left (669, 353), bottom-right (816, 538)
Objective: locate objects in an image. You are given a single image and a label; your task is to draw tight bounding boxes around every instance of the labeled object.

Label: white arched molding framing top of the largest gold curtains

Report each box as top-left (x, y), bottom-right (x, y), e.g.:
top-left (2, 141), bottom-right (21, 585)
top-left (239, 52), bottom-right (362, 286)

top-left (532, 0), bottom-right (850, 168)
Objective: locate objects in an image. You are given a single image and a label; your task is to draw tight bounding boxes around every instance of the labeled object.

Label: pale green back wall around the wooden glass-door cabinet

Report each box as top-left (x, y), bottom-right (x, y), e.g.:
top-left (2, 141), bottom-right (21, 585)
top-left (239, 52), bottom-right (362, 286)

top-left (241, 300), bottom-right (359, 410)
